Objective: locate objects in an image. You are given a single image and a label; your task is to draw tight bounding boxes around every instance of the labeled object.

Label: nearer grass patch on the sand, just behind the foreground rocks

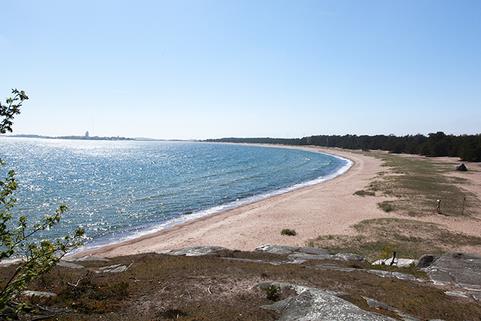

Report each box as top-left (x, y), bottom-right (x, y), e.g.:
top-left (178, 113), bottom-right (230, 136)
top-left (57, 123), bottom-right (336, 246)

top-left (309, 218), bottom-right (481, 260)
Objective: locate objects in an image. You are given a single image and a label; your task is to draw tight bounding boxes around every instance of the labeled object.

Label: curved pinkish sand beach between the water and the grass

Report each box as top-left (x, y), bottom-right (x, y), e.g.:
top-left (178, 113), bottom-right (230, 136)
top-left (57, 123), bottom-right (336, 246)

top-left (71, 144), bottom-right (386, 257)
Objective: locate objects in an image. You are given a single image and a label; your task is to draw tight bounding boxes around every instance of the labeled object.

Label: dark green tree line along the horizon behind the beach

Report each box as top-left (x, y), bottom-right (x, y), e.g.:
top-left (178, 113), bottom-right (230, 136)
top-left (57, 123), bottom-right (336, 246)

top-left (204, 132), bottom-right (481, 162)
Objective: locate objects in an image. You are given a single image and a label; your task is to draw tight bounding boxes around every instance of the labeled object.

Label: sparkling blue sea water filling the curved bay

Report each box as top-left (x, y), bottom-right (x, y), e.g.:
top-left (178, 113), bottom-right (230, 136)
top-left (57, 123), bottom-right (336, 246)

top-left (0, 138), bottom-right (350, 246)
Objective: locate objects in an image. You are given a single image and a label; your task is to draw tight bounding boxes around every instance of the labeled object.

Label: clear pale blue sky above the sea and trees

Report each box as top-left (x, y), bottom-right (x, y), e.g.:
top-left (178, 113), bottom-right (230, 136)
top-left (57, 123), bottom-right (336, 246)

top-left (0, 0), bottom-right (481, 139)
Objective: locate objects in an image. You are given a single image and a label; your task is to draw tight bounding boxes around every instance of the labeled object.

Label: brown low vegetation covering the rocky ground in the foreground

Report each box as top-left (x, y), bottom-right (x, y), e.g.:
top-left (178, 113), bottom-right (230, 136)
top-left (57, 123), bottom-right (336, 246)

top-left (0, 251), bottom-right (481, 321)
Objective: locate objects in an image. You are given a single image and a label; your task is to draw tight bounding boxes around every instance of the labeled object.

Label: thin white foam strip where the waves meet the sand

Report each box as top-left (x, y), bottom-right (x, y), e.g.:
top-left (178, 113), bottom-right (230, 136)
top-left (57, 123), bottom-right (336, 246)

top-left (72, 151), bottom-right (353, 253)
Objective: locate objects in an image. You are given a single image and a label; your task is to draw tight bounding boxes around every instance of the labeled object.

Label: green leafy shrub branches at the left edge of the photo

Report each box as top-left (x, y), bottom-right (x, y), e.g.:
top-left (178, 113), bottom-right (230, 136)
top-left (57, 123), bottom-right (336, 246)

top-left (0, 89), bottom-right (84, 320)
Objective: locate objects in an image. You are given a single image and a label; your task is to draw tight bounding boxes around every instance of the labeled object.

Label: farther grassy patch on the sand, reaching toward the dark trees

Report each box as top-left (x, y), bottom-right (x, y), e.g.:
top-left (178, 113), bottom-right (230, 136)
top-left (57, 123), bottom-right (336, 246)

top-left (355, 152), bottom-right (480, 216)
